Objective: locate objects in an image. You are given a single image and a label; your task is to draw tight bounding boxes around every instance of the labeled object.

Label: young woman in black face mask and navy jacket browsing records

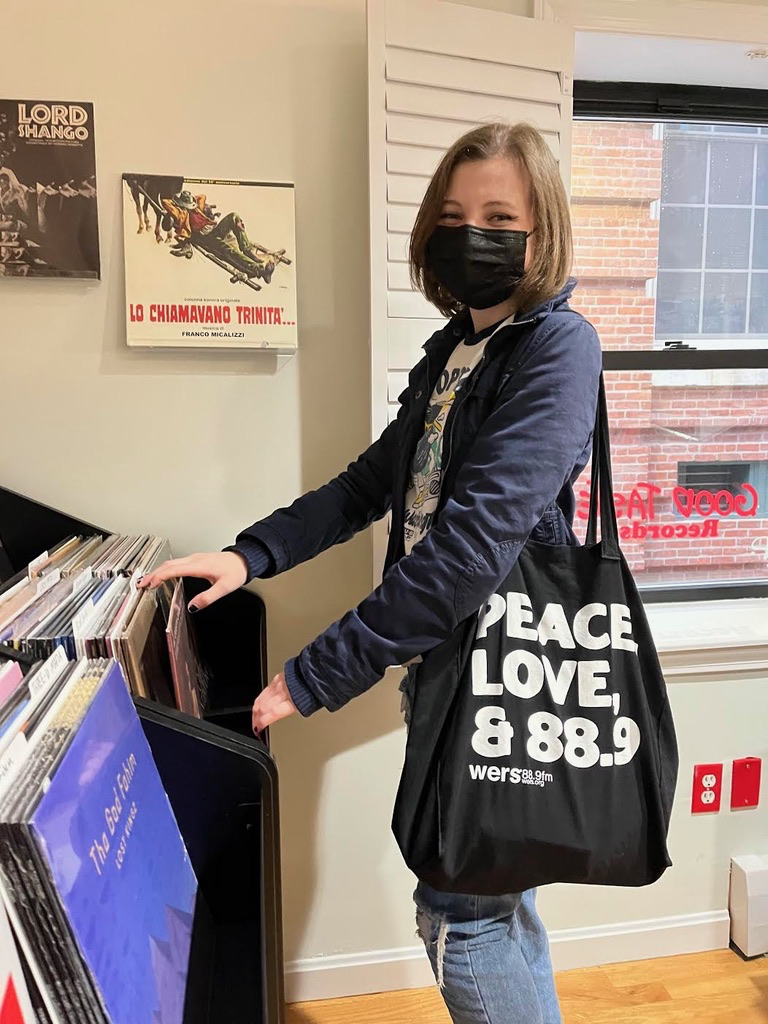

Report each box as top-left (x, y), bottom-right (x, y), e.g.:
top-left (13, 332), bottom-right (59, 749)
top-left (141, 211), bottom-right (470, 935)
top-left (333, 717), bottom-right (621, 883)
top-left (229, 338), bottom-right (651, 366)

top-left (142, 124), bottom-right (601, 1024)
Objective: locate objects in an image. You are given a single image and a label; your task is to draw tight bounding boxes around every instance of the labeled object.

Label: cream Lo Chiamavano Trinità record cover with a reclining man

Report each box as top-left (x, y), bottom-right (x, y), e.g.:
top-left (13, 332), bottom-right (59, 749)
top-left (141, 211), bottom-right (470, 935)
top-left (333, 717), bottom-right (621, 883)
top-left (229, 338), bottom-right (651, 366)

top-left (123, 174), bottom-right (297, 352)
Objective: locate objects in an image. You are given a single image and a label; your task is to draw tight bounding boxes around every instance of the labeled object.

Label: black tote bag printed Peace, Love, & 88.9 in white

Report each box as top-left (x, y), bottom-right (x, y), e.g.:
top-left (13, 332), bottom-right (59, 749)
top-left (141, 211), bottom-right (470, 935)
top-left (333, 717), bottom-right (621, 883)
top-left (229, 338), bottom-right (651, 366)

top-left (393, 378), bottom-right (678, 895)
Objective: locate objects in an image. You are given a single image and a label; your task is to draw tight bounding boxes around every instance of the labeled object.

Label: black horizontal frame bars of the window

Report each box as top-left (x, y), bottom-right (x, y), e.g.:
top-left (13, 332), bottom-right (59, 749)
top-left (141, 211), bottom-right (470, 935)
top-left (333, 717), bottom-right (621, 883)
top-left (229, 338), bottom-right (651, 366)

top-left (573, 86), bottom-right (768, 603)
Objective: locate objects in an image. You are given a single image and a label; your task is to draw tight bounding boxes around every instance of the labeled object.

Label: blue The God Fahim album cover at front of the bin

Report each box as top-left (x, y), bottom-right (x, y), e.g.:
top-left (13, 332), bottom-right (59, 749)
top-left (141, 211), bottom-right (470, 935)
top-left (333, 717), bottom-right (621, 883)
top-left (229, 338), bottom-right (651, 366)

top-left (31, 665), bottom-right (197, 1024)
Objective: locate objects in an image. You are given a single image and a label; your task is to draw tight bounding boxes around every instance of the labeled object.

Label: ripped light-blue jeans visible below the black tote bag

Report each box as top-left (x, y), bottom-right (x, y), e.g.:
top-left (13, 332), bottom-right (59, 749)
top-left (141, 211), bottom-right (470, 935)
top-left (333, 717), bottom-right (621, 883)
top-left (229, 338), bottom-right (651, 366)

top-left (414, 882), bottom-right (561, 1024)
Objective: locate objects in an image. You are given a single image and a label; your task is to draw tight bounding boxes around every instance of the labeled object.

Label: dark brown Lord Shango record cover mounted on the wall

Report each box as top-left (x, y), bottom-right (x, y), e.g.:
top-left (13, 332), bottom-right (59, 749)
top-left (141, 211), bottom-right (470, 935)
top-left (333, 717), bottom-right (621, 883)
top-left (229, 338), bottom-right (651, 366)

top-left (0, 99), bottom-right (99, 280)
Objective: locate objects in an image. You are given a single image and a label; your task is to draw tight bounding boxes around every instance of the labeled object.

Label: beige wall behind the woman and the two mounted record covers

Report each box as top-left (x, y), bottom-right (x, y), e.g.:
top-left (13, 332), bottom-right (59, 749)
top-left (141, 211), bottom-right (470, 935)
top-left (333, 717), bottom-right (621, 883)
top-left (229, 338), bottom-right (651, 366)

top-left (0, 0), bottom-right (768, 983)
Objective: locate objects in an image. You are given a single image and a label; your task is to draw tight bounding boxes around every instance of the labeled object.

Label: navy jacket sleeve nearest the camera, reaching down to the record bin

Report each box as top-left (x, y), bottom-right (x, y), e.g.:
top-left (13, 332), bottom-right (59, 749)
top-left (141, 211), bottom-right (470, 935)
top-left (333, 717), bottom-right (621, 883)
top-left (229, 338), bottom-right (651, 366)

top-left (286, 319), bottom-right (601, 715)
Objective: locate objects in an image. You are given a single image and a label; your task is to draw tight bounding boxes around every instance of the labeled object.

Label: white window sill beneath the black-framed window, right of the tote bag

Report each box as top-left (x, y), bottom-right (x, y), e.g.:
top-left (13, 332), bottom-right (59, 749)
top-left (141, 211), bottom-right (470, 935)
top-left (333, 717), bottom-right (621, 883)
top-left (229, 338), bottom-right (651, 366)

top-left (645, 598), bottom-right (768, 682)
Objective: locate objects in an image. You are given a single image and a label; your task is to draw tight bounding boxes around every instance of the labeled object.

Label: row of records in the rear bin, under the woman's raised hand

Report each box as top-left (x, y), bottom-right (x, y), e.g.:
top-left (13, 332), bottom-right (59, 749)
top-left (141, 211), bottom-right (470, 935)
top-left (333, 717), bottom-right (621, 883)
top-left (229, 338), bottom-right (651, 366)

top-left (0, 535), bottom-right (208, 718)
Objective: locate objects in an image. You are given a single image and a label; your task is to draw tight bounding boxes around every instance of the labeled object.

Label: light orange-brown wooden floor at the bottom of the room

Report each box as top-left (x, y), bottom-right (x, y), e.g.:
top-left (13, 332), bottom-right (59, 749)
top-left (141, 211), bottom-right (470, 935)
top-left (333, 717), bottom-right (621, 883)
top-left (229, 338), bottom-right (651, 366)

top-left (286, 951), bottom-right (768, 1024)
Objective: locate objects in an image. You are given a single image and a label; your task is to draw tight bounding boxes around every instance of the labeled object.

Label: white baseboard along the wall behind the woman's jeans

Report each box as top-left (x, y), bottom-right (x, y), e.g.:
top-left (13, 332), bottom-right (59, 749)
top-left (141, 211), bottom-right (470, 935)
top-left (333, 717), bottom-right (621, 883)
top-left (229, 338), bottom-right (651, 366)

top-left (286, 910), bottom-right (730, 1002)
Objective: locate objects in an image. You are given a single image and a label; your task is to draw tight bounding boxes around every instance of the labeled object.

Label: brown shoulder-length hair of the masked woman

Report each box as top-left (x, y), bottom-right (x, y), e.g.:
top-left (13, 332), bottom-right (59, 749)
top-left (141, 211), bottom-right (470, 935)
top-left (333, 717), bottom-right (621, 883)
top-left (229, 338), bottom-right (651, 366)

top-left (409, 123), bottom-right (573, 316)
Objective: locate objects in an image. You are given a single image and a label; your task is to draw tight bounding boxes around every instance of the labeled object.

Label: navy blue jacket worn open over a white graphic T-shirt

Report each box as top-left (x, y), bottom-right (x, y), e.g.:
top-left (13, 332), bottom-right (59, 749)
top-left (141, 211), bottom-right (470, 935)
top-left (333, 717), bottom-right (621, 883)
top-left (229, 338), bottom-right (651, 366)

top-left (230, 281), bottom-right (601, 715)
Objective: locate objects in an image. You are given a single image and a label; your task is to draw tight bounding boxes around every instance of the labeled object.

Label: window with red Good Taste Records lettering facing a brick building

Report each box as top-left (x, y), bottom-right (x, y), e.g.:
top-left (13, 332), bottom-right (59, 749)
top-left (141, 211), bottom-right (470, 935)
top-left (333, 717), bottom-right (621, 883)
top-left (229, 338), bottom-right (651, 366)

top-left (571, 82), bottom-right (768, 601)
